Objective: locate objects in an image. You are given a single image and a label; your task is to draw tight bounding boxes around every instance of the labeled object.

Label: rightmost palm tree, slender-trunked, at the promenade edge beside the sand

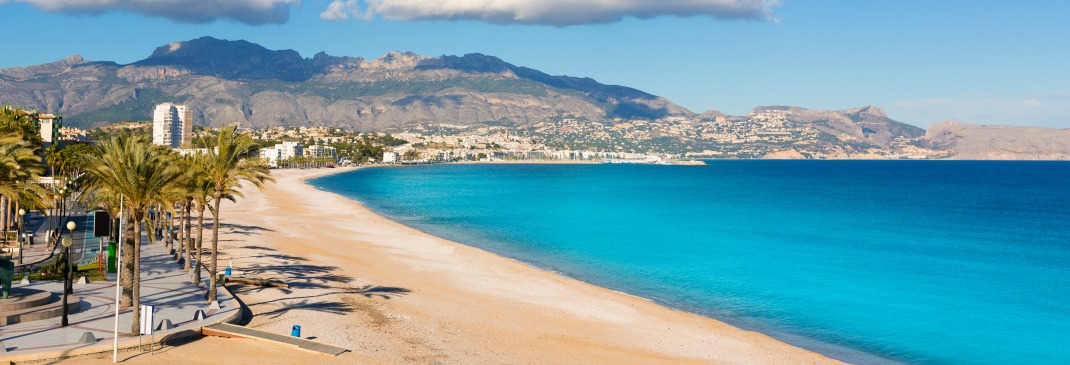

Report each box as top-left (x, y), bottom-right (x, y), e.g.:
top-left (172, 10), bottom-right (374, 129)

top-left (202, 126), bottom-right (275, 302)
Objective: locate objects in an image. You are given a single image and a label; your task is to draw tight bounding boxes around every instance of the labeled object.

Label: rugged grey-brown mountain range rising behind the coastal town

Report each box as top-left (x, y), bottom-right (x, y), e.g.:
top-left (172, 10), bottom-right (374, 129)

top-left (0, 36), bottom-right (1070, 158)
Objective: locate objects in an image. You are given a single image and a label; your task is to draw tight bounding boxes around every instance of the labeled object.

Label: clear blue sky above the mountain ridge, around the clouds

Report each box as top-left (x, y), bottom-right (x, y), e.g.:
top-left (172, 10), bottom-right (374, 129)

top-left (0, 0), bottom-right (1070, 128)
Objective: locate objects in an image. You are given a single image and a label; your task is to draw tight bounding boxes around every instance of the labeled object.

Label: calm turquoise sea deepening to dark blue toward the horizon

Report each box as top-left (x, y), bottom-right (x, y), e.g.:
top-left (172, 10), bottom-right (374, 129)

top-left (312, 161), bottom-right (1070, 364)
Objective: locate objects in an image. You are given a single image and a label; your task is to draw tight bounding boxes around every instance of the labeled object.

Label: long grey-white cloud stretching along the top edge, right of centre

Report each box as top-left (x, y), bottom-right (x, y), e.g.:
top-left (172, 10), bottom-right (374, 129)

top-left (350, 0), bottom-right (779, 27)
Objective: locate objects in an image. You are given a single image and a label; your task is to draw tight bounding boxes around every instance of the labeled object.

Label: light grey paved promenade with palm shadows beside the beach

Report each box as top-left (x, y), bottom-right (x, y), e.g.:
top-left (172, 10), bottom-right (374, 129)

top-left (0, 240), bottom-right (241, 362)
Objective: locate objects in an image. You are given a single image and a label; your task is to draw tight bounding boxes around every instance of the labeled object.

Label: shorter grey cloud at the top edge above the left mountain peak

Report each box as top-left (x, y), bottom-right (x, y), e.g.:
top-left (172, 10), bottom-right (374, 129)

top-left (9, 0), bottom-right (301, 25)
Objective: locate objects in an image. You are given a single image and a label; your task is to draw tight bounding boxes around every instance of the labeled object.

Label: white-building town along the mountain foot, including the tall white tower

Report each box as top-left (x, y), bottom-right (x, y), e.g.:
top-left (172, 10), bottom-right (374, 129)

top-left (29, 103), bottom-right (947, 168)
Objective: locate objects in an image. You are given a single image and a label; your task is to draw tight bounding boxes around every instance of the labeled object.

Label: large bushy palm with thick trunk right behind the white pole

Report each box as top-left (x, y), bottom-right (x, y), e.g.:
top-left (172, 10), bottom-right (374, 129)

top-left (86, 133), bottom-right (182, 333)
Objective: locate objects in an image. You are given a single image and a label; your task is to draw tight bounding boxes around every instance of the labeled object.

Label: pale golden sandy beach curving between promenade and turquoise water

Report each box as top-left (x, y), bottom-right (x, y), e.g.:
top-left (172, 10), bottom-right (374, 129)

top-left (62, 165), bottom-right (839, 364)
